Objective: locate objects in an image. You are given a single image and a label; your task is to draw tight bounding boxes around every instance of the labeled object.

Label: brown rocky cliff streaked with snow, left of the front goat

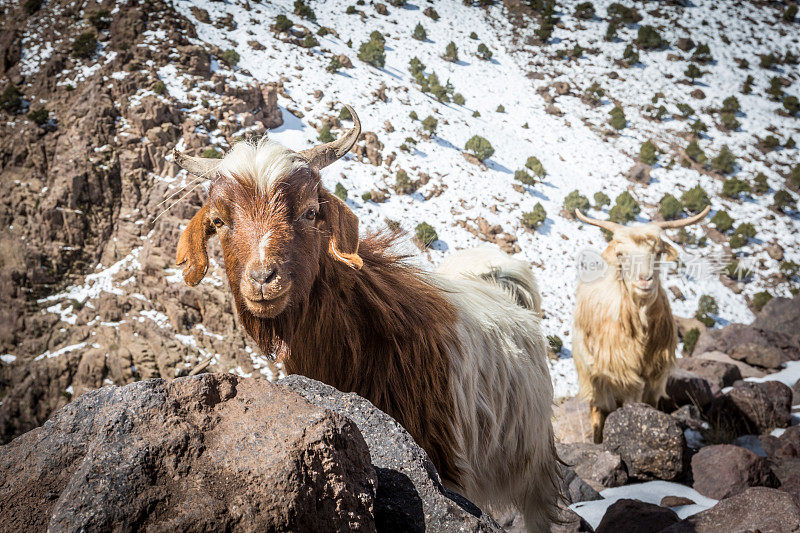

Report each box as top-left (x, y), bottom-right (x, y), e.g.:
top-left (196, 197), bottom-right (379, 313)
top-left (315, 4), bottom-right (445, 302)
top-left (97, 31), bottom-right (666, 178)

top-left (0, 0), bottom-right (282, 442)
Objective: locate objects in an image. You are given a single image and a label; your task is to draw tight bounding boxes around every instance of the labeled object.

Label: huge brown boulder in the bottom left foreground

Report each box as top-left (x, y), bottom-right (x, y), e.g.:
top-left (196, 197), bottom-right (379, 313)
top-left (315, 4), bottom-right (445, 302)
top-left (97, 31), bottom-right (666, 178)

top-left (0, 374), bottom-right (377, 531)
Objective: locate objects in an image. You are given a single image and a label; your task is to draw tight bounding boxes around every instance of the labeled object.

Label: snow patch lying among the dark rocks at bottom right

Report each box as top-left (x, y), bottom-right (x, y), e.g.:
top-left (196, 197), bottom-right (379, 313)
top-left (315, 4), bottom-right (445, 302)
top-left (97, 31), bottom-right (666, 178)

top-left (570, 481), bottom-right (717, 528)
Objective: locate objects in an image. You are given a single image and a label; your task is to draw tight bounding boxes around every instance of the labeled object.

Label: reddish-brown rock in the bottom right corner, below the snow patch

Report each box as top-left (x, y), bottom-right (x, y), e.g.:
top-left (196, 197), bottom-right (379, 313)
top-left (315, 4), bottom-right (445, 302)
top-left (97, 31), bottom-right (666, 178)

top-left (661, 487), bottom-right (800, 533)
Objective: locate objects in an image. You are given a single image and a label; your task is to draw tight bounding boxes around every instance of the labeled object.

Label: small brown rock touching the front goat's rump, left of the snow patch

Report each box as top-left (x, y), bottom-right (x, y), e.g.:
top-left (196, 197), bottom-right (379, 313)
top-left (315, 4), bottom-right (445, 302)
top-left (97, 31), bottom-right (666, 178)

top-left (556, 442), bottom-right (628, 491)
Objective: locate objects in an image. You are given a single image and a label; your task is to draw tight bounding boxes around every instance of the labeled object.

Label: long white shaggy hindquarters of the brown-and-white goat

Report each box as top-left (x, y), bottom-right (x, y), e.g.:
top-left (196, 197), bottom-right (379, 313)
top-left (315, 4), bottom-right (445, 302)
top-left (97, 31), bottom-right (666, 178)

top-left (434, 247), bottom-right (559, 531)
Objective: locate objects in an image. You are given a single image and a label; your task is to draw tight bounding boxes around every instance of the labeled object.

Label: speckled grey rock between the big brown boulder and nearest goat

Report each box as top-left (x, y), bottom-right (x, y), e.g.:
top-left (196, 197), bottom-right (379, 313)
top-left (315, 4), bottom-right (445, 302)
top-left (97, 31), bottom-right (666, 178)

top-left (278, 375), bottom-right (500, 531)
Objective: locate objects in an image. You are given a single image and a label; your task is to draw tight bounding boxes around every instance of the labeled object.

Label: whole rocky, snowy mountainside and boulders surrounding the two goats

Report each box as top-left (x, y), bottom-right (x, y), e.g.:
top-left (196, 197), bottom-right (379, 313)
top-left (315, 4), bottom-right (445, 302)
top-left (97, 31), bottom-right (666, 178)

top-left (0, 0), bottom-right (800, 531)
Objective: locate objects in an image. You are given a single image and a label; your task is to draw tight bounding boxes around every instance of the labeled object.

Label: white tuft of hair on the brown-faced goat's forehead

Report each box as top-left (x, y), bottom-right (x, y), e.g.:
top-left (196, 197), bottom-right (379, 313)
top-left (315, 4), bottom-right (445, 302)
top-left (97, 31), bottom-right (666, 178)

top-left (219, 136), bottom-right (308, 192)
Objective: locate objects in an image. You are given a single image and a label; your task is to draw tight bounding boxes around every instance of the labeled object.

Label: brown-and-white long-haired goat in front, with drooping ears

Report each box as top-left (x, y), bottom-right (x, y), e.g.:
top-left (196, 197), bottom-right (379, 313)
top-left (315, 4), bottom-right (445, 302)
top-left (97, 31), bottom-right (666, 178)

top-left (175, 107), bottom-right (558, 530)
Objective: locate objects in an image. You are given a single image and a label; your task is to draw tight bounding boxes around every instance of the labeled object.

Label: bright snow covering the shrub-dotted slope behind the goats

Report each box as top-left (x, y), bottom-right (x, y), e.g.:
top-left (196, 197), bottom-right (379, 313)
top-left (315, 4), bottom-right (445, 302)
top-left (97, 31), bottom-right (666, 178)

top-left (167, 0), bottom-right (800, 396)
